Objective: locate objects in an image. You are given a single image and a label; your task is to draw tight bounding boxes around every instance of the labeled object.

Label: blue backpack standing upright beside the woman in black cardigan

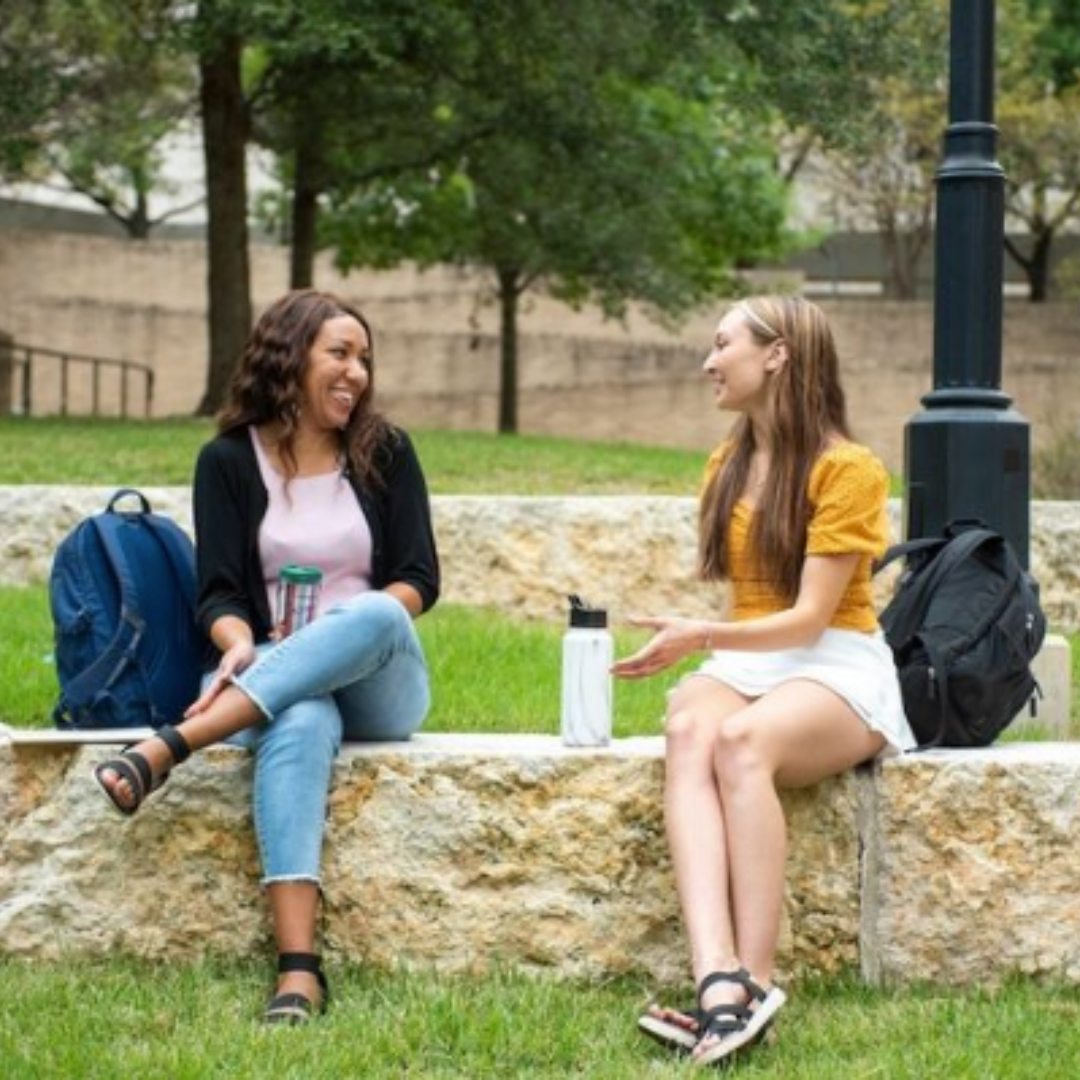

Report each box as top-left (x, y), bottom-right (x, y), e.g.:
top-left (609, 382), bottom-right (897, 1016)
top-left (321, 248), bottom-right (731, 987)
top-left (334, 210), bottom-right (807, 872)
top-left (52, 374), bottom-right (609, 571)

top-left (49, 488), bottom-right (205, 730)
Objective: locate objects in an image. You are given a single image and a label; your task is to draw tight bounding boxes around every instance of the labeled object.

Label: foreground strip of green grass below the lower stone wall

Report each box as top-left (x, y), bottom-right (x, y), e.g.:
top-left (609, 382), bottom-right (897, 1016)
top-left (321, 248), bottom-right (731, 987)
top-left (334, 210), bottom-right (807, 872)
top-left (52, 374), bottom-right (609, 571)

top-left (0, 959), bottom-right (1080, 1080)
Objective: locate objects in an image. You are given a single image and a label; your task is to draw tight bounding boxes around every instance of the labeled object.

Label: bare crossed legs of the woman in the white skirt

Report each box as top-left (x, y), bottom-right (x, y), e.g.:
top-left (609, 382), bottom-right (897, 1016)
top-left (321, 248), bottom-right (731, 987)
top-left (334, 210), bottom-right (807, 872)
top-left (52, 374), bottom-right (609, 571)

top-left (664, 677), bottom-right (883, 1056)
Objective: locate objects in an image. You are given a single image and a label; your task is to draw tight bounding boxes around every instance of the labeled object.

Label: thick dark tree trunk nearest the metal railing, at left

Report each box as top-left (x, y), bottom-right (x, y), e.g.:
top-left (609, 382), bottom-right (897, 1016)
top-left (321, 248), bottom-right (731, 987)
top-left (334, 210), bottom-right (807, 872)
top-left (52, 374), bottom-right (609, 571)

top-left (198, 22), bottom-right (252, 416)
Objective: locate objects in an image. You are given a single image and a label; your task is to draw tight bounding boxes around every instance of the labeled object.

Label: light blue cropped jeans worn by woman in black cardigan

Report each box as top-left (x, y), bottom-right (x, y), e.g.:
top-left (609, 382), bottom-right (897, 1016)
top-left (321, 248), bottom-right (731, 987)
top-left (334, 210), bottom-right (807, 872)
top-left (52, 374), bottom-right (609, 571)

top-left (220, 592), bottom-right (431, 885)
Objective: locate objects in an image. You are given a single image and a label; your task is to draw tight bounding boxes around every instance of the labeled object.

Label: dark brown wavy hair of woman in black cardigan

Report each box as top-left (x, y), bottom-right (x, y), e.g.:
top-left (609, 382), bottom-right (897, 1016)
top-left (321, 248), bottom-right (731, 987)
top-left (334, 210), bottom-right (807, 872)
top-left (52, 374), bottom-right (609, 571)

top-left (217, 288), bottom-right (393, 487)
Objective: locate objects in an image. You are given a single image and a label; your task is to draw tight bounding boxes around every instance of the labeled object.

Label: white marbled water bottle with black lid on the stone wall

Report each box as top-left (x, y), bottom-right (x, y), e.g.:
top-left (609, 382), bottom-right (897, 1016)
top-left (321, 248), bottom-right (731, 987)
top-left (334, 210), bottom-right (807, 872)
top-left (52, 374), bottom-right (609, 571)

top-left (561, 596), bottom-right (615, 746)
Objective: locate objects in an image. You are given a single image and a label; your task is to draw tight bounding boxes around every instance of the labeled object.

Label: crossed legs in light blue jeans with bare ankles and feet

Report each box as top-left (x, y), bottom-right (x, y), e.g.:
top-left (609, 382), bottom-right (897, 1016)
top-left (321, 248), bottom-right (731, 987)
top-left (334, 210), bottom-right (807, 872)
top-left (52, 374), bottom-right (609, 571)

top-left (98, 593), bottom-right (430, 1003)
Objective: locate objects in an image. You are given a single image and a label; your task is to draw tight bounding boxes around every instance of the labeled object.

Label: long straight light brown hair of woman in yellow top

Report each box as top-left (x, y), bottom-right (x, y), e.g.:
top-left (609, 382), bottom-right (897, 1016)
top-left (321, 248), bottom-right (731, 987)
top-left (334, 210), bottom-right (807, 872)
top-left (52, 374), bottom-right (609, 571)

top-left (698, 296), bottom-right (851, 600)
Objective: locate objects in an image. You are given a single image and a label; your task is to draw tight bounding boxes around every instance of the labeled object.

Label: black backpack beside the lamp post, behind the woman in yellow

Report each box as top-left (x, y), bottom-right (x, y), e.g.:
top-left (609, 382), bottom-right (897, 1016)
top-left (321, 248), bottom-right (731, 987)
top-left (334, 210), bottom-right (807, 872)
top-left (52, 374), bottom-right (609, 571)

top-left (875, 523), bottom-right (1047, 747)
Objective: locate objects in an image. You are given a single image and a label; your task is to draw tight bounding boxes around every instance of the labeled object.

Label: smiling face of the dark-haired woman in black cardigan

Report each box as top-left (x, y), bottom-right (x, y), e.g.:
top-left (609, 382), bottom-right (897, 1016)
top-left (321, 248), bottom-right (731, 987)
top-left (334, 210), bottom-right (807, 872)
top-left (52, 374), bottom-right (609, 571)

top-left (300, 315), bottom-right (372, 431)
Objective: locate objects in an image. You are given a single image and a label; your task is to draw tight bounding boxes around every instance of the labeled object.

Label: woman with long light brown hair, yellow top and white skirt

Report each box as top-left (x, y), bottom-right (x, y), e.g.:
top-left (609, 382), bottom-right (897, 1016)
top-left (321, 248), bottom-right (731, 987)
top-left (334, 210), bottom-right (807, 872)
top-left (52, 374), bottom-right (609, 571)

top-left (613, 296), bottom-right (915, 1065)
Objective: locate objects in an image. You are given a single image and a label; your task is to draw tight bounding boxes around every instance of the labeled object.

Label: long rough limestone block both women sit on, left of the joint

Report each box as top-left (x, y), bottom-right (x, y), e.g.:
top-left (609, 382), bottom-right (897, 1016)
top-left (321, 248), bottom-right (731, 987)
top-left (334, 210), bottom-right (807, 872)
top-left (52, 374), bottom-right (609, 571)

top-left (0, 734), bottom-right (860, 982)
